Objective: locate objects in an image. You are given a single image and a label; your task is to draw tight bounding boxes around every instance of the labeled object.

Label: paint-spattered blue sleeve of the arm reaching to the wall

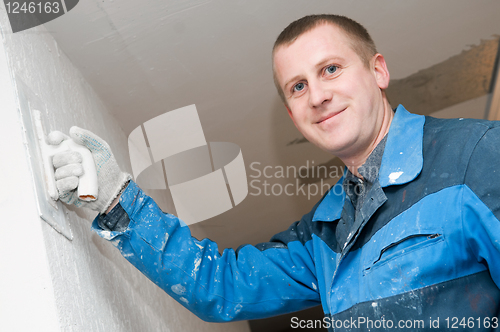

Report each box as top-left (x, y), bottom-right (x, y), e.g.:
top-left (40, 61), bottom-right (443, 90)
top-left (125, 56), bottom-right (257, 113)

top-left (92, 182), bottom-right (320, 322)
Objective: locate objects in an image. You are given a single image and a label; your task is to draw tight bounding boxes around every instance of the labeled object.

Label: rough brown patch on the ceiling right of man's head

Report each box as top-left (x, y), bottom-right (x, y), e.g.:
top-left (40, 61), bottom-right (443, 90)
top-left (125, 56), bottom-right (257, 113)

top-left (386, 36), bottom-right (500, 115)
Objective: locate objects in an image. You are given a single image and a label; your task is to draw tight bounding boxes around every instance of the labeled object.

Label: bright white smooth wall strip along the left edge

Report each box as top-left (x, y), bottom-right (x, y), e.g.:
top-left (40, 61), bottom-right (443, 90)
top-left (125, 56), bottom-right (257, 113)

top-left (0, 12), bottom-right (59, 331)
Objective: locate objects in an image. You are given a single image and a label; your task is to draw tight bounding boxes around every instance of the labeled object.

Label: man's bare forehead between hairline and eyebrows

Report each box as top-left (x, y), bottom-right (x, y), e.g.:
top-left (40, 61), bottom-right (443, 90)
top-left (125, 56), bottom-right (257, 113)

top-left (273, 23), bottom-right (359, 86)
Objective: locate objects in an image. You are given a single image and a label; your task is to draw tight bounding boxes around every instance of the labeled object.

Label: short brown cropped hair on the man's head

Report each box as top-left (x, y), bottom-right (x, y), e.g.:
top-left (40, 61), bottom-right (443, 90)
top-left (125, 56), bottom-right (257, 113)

top-left (272, 14), bottom-right (377, 103)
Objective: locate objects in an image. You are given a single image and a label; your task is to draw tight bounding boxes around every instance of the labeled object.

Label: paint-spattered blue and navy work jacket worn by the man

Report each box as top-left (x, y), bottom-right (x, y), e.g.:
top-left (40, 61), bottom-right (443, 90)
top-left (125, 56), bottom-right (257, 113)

top-left (93, 105), bottom-right (500, 331)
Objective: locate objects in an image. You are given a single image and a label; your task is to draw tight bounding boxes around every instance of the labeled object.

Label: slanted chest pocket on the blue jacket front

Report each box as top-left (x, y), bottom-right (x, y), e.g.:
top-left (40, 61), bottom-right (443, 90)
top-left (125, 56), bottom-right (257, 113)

top-left (363, 231), bottom-right (444, 275)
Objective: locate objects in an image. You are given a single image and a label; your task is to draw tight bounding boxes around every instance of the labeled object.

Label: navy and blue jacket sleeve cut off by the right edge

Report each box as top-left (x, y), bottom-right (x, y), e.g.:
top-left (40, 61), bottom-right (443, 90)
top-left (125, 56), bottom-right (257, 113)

top-left (462, 122), bottom-right (500, 288)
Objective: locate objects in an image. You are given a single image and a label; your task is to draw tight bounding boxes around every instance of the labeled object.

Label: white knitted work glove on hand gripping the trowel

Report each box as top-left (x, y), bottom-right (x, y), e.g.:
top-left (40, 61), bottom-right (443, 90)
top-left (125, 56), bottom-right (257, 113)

top-left (47, 126), bottom-right (131, 214)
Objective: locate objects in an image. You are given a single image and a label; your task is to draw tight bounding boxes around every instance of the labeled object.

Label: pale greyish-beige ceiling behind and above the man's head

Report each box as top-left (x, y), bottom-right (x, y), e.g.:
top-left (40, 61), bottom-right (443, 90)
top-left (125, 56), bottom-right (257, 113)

top-left (45, 0), bottom-right (500, 252)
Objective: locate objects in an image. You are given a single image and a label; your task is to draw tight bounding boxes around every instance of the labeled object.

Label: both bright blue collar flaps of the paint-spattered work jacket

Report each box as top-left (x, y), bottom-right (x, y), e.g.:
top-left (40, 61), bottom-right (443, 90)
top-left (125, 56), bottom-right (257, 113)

top-left (312, 105), bottom-right (425, 221)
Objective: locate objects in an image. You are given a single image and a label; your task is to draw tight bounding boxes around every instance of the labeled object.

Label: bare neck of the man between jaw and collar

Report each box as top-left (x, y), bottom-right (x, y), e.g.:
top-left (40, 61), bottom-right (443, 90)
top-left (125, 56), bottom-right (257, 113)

top-left (340, 99), bottom-right (394, 178)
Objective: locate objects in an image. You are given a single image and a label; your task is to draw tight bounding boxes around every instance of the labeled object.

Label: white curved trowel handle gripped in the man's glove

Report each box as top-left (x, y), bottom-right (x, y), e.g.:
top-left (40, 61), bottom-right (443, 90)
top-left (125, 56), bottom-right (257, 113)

top-left (60, 139), bottom-right (99, 202)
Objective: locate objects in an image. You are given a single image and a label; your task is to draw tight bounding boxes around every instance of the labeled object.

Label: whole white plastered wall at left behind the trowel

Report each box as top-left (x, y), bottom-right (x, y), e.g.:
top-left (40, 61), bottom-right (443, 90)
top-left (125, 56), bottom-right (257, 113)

top-left (0, 6), bottom-right (249, 332)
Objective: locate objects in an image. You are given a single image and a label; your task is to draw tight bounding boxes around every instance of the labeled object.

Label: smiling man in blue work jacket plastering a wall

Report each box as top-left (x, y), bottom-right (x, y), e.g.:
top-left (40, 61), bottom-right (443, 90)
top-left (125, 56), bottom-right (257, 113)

top-left (50, 15), bottom-right (500, 330)
